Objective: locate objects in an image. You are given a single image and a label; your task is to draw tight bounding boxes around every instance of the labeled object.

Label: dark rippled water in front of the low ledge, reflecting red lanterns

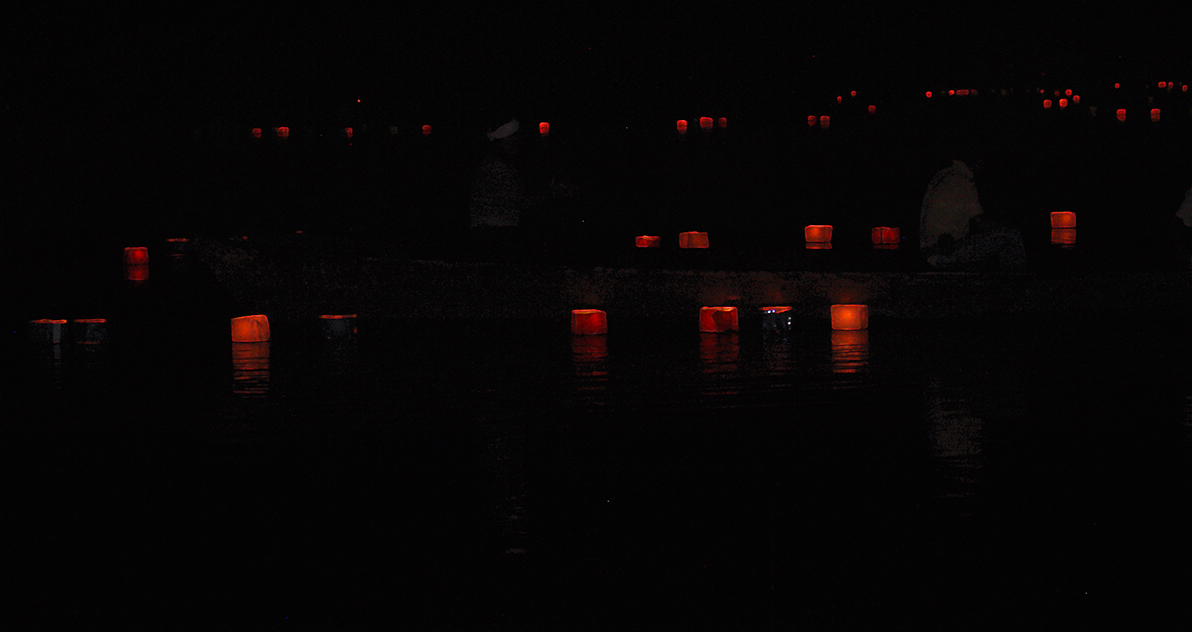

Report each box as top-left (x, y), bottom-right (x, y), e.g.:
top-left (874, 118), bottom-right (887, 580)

top-left (5, 249), bottom-right (1192, 630)
